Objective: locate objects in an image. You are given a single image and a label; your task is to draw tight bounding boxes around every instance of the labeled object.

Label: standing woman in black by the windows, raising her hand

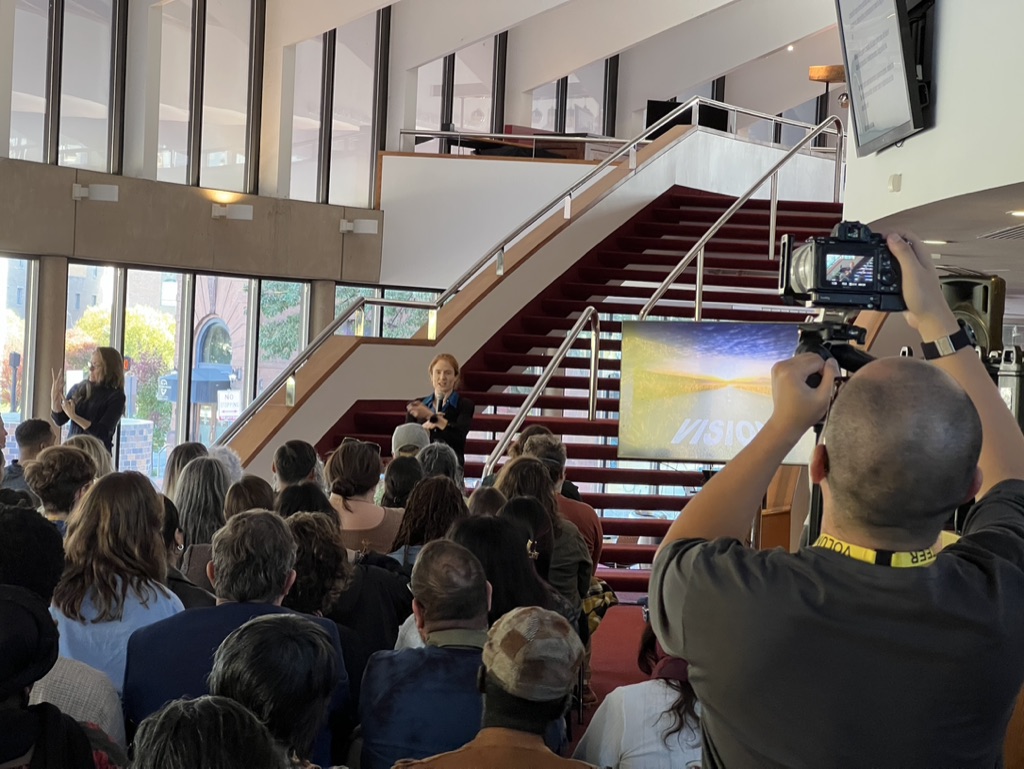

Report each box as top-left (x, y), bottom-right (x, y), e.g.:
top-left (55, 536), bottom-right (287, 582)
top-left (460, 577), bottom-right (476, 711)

top-left (50, 347), bottom-right (125, 452)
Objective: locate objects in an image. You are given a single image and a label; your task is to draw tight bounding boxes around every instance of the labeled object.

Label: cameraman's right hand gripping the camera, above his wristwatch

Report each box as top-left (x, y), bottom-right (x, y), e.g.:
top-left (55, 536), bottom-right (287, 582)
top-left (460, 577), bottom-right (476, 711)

top-left (886, 232), bottom-right (956, 341)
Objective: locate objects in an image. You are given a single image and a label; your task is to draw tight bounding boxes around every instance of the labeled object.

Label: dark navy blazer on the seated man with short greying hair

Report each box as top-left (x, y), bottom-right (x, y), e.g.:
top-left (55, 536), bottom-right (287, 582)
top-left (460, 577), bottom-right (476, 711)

top-left (123, 603), bottom-right (348, 764)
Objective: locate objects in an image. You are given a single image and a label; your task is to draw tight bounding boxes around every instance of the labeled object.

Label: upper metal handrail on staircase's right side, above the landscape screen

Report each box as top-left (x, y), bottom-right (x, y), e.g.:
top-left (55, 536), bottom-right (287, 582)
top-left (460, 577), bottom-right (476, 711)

top-left (639, 115), bottom-right (843, 321)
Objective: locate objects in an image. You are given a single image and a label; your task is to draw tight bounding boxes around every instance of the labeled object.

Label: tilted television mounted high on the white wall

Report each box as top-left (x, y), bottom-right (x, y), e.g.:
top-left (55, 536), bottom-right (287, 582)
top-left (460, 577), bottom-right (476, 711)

top-left (836, 0), bottom-right (932, 157)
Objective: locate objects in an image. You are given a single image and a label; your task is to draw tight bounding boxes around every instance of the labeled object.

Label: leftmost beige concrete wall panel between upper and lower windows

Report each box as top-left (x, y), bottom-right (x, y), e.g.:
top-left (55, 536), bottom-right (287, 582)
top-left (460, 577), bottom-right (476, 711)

top-left (0, 159), bottom-right (75, 254)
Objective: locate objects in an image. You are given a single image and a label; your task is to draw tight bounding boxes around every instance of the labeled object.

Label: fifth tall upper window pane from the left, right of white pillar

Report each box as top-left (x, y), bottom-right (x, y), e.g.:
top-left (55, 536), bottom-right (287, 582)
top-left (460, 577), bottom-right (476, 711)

top-left (289, 35), bottom-right (324, 202)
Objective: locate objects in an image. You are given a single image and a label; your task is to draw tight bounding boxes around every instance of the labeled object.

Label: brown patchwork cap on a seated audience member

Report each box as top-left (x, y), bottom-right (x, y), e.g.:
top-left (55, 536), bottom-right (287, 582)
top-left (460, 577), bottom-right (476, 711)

top-left (483, 606), bottom-right (584, 702)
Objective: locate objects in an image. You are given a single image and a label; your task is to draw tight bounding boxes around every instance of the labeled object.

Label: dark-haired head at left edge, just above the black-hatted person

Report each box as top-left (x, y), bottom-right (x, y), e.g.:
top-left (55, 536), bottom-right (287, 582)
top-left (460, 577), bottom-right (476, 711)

top-left (0, 506), bottom-right (65, 605)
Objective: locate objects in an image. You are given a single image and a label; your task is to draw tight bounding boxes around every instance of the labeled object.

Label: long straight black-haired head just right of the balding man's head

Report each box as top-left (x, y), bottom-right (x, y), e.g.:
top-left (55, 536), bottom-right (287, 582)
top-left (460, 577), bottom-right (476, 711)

top-left (449, 515), bottom-right (552, 624)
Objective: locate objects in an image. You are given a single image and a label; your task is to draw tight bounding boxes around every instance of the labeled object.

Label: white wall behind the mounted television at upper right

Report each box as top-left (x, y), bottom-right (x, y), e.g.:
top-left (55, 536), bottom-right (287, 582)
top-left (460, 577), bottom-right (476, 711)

top-left (846, 0), bottom-right (1024, 225)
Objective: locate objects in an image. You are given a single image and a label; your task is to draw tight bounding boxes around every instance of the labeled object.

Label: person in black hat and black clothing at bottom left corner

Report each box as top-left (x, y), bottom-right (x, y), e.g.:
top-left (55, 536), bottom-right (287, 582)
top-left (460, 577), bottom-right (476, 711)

top-left (0, 585), bottom-right (128, 769)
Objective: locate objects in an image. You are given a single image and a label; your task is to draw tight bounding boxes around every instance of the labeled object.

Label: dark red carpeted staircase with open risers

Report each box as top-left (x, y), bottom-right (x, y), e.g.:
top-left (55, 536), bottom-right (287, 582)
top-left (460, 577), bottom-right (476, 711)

top-left (317, 187), bottom-right (842, 592)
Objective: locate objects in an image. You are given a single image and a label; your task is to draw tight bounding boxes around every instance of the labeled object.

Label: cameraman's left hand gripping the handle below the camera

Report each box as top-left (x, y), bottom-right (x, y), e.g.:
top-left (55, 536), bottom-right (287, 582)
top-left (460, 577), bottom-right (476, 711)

top-left (771, 352), bottom-right (839, 443)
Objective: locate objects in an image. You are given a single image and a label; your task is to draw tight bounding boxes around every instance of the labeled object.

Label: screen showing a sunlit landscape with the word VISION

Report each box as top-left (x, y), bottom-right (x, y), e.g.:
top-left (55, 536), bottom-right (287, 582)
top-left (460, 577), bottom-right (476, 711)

top-left (618, 321), bottom-right (814, 464)
